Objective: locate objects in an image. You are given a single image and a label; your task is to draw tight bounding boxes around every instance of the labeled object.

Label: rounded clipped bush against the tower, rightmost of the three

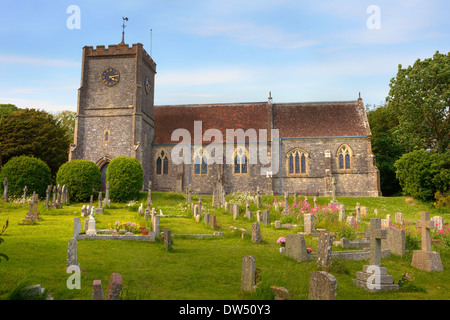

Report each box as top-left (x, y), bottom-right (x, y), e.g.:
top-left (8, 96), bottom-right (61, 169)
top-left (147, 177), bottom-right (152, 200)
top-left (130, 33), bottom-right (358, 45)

top-left (106, 157), bottom-right (144, 202)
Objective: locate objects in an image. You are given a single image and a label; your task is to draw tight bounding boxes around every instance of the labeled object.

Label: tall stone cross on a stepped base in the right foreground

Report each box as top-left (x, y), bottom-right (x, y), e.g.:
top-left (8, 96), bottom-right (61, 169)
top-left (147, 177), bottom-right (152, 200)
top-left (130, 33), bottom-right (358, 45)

top-left (354, 219), bottom-right (399, 292)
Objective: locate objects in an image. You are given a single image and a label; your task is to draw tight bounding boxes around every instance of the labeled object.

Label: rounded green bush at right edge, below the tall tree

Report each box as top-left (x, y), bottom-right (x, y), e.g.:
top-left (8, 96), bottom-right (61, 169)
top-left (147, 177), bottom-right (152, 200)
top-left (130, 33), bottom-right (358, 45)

top-left (395, 150), bottom-right (450, 201)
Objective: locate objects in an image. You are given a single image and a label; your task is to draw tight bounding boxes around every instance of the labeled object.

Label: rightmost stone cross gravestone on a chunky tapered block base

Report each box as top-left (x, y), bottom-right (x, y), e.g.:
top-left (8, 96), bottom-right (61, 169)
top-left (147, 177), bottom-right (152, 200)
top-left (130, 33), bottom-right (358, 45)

top-left (411, 212), bottom-right (444, 272)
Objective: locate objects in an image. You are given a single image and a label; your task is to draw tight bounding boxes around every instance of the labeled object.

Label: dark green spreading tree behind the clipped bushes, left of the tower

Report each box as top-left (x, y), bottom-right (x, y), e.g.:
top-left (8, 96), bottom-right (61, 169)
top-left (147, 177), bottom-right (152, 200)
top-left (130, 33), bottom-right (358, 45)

top-left (0, 109), bottom-right (70, 177)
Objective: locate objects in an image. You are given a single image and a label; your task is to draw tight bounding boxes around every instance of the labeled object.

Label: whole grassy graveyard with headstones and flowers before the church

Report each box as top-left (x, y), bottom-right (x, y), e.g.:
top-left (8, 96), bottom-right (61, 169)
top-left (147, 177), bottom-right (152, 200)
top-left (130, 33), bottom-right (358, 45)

top-left (0, 192), bottom-right (450, 300)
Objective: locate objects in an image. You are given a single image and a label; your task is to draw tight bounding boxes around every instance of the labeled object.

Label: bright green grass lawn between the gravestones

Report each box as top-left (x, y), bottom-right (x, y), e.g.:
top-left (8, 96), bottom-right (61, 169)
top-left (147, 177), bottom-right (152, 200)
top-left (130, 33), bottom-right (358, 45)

top-left (0, 192), bottom-right (450, 300)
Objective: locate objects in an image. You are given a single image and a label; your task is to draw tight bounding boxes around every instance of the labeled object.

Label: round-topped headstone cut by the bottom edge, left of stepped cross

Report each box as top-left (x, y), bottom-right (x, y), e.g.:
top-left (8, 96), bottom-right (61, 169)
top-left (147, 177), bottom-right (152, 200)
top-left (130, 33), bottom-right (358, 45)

top-left (308, 271), bottom-right (337, 300)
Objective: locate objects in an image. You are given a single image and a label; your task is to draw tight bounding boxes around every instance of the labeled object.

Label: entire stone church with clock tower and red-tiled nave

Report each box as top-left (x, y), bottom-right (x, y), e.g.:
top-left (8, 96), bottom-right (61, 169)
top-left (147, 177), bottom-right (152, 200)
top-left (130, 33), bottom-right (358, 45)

top-left (69, 43), bottom-right (381, 196)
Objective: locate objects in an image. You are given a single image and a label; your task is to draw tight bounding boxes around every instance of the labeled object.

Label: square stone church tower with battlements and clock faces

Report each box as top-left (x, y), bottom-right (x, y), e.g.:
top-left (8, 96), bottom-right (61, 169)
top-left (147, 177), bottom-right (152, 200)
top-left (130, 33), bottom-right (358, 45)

top-left (69, 42), bottom-right (156, 188)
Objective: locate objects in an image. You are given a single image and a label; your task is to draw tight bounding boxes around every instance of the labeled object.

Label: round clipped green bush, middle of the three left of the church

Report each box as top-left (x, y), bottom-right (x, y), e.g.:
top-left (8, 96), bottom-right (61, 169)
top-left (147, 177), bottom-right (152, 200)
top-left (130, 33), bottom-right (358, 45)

top-left (56, 160), bottom-right (102, 202)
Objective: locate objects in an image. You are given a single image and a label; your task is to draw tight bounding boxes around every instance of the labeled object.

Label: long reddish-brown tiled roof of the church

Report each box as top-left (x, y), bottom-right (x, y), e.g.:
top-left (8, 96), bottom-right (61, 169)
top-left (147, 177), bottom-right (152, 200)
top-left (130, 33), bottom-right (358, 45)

top-left (153, 101), bottom-right (370, 144)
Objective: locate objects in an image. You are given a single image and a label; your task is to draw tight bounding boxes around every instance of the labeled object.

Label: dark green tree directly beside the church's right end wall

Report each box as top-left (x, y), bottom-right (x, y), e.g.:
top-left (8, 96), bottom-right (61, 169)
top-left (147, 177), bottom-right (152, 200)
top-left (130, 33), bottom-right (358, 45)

top-left (367, 105), bottom-right (405, 196)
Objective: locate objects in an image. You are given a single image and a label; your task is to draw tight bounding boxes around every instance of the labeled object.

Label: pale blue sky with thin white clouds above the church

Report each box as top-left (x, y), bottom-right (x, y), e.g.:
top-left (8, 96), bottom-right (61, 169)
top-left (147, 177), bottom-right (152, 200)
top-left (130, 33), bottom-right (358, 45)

top-left (0, 0), bottom-right (450, 113)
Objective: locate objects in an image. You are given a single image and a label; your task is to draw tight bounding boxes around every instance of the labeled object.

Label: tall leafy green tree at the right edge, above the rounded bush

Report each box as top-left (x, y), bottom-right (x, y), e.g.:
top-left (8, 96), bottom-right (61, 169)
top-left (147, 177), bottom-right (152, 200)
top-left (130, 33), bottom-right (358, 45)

top-left (386, 51), bottom-right (450, 153)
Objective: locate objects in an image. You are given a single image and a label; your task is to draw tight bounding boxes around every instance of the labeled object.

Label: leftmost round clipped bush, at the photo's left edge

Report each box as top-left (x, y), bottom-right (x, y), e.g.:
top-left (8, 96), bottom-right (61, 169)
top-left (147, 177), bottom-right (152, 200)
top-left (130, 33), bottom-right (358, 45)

top-left (0, 156), bottom-right (52, 198)
